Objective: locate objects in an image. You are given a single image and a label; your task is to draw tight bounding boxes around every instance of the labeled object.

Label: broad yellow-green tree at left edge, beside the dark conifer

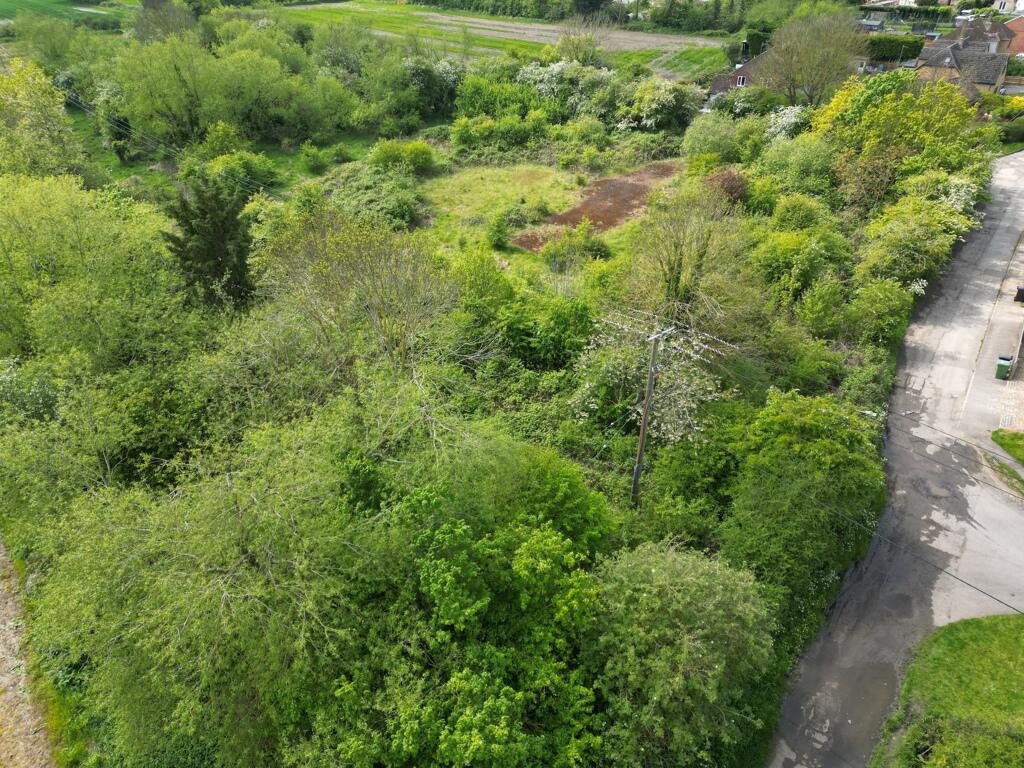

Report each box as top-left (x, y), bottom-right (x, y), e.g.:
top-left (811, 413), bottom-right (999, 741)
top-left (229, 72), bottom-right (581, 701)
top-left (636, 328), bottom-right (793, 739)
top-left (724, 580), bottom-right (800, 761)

top-left (0, 176), bottom-right (190, 372)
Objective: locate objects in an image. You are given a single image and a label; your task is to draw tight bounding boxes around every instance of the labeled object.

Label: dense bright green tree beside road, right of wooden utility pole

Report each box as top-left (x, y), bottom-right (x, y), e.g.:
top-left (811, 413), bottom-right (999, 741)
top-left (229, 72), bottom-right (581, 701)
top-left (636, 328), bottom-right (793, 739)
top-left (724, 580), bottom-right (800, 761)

top-left (720, 392), bottom-right (885, 649)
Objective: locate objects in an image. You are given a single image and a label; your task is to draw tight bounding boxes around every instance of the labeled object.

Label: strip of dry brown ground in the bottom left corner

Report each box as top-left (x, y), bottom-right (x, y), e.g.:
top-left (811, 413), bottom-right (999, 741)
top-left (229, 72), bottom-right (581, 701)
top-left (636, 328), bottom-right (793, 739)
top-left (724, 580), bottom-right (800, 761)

top-left (0, 544), bottom-right (53, 768)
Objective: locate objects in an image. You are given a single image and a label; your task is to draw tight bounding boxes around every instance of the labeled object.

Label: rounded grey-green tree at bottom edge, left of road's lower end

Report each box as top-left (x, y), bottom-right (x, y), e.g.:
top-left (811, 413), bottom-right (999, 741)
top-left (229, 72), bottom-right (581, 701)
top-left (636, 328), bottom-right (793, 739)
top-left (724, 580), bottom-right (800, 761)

top-left (585, 544), bottom-right (771, 768)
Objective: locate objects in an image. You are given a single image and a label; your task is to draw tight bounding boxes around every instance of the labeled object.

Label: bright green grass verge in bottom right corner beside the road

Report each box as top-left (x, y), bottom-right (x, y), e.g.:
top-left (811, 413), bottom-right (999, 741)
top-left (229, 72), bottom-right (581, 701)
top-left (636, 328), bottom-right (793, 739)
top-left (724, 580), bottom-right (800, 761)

top-left (870, 615), bottom-right (1024, 768)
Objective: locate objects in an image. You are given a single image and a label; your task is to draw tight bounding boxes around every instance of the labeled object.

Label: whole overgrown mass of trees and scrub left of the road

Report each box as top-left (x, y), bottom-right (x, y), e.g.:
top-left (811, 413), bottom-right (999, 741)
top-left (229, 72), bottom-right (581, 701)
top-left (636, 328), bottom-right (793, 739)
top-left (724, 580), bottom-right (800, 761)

top-left (0, 6), bottom-right (996, 768)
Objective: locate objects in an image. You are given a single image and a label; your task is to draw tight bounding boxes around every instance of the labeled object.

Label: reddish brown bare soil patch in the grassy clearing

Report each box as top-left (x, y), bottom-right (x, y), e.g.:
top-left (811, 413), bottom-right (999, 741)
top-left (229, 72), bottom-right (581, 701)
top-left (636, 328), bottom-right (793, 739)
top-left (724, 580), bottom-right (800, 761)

top-left (512, 162), bottom-right (679, 252)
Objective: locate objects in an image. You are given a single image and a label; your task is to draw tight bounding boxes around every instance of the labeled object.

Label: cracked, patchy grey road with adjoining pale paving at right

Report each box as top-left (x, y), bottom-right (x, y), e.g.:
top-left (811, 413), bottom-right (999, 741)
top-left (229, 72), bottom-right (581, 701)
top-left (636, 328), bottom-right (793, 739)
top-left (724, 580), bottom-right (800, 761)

top-left (769, 153), bottom-right (1024, 768)
